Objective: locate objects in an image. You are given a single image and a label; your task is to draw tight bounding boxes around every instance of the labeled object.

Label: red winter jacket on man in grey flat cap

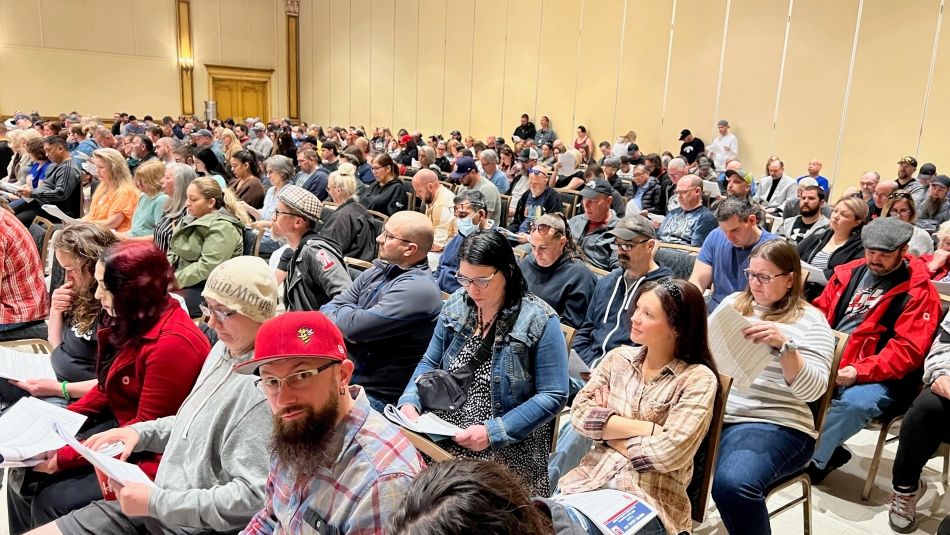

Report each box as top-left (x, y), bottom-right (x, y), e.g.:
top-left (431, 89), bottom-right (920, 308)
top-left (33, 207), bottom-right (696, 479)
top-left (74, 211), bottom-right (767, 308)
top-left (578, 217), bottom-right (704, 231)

top-left (813, 255), bottom-right (940, 383)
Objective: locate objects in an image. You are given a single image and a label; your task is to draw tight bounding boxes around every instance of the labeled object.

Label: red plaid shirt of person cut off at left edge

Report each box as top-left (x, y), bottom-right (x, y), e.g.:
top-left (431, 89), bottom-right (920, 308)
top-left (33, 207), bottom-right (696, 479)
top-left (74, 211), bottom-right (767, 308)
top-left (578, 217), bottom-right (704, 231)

top-left (0, 209), bottom-right (49, 325)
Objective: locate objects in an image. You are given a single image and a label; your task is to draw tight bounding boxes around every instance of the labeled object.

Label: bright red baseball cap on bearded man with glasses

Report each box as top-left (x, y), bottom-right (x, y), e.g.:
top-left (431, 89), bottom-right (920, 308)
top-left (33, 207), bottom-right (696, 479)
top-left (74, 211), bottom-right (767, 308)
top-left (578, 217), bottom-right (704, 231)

top-left (234, 311), bottom-right (346, 375)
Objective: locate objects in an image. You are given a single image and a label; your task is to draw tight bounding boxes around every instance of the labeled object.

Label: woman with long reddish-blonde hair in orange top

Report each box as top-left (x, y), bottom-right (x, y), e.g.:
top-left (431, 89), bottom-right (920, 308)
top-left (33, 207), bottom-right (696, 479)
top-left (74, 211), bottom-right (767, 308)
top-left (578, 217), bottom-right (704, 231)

top-left (83, 149), bottom-right (139, 232)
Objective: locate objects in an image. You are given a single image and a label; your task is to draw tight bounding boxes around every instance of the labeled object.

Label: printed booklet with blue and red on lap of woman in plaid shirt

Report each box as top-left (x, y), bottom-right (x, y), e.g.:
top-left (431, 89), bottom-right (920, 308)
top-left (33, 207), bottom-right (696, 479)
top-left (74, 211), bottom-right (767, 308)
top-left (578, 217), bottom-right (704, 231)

top-left (551, 489), bottom-right (657, 535)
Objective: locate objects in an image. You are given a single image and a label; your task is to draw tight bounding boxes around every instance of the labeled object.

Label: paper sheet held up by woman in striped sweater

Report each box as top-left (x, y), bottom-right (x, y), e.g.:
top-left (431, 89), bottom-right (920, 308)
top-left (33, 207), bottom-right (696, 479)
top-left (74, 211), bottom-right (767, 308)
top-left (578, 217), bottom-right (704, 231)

top-left (709, 305), bottom-right (772, 390)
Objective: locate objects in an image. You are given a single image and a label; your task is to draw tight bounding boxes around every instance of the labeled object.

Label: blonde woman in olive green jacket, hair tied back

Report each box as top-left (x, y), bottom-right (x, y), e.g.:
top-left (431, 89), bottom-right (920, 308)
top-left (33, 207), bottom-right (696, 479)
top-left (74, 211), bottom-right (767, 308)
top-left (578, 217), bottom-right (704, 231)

top-left (168, 177), bottom-right (251, 317)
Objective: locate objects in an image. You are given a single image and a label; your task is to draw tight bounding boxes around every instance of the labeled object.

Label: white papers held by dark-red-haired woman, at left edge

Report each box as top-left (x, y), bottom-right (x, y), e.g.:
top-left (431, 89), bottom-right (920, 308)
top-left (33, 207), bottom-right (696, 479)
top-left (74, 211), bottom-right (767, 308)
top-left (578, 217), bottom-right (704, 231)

top-left (0, 397), bottom-right (86, 461)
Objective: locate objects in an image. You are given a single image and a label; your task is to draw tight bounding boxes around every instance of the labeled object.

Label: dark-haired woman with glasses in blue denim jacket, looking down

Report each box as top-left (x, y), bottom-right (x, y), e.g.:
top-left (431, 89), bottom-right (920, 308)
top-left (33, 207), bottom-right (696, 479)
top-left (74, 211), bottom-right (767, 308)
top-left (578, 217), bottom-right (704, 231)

top-left (398, 230), bottom-right (568, 496)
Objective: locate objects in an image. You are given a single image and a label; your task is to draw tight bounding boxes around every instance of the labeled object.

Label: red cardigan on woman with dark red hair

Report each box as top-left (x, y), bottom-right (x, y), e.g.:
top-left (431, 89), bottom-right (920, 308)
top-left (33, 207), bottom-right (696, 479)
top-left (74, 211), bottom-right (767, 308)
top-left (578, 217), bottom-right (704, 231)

top-left (56, 297), bottom-right (211, 478)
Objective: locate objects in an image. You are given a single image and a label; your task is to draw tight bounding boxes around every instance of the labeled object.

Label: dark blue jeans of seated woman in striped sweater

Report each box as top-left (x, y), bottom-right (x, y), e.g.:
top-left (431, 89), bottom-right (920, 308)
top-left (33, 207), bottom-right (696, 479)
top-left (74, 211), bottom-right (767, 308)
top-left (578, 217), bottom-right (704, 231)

top-left (712, 423), bottom-right (815, 535)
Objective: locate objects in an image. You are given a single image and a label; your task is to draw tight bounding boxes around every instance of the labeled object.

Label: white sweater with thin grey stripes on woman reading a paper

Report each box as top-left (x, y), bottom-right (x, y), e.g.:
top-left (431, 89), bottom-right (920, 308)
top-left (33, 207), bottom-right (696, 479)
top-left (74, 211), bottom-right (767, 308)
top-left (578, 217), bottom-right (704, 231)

top-left (714, 293), bottom-right (835, 438)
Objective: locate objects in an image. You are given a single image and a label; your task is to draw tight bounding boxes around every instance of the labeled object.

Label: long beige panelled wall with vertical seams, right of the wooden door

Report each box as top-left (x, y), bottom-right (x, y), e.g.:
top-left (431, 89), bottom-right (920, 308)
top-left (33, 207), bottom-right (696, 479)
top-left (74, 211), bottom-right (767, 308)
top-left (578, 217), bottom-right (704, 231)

top-left (301, 0), bottom-right (950, 192)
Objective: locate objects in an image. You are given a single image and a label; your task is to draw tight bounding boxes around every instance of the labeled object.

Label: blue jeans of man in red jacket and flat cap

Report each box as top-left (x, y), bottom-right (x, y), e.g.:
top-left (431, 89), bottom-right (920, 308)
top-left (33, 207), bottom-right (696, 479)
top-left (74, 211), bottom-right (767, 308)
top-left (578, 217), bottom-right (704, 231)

top-left (811, 383), bottom-right (894, 469)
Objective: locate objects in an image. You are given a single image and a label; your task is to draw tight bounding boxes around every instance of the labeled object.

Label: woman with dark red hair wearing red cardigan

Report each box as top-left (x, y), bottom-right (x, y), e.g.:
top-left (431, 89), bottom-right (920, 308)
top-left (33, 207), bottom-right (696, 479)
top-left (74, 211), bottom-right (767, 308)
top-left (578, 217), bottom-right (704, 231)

top-left (8, 241), bottom-right (211, 534)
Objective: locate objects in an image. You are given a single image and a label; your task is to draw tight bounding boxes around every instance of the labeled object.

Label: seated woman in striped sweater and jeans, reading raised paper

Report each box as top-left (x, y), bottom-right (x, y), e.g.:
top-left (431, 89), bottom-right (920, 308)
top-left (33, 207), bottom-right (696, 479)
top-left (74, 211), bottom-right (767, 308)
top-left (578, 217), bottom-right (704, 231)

top-left (712, 240), bottom-right (836, 535)
